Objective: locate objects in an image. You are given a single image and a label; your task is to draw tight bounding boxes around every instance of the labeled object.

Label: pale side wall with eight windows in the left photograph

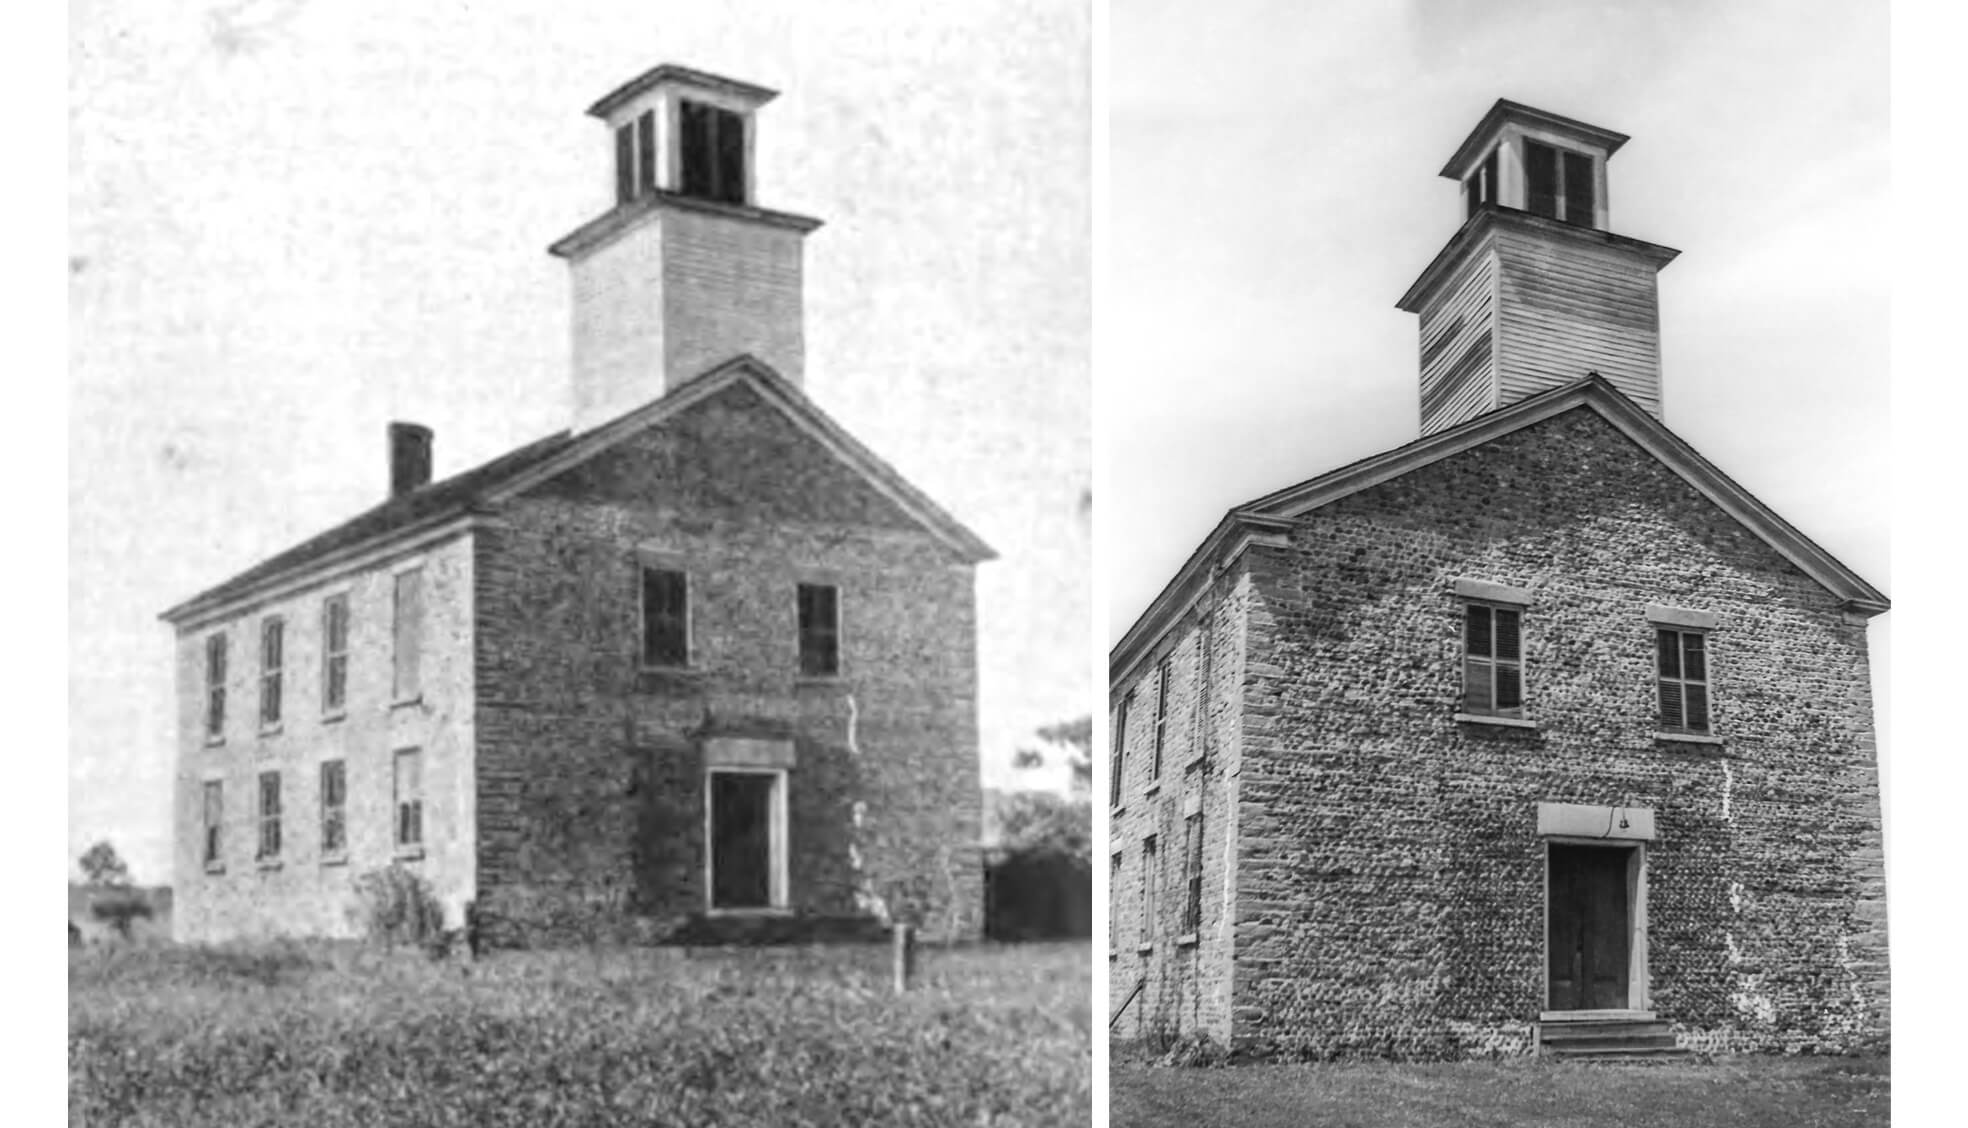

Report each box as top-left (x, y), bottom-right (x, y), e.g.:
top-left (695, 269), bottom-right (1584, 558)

top-left (173, 533), bottom-right (474, 943)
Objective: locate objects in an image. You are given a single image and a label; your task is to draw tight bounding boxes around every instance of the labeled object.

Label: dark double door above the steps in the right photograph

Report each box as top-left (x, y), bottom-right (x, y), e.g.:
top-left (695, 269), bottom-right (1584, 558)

top-left (1547, 843), bottom-right (1631, 1010)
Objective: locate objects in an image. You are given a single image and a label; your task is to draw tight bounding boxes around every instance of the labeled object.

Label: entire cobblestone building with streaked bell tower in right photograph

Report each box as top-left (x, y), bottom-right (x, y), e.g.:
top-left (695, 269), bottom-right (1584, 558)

top-left (1108, 102), bottom-right (1887, 1057)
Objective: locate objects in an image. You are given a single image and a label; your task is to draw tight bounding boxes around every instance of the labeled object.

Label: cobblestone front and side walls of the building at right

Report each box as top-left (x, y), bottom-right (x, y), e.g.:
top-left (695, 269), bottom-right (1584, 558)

top-left (1110, 407), bottom-right (1889, 1059)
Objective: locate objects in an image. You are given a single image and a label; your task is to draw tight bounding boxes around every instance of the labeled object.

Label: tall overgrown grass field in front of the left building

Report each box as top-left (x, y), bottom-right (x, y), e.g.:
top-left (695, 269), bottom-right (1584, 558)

top-left (69, 943), bottom-right (1092, 1128)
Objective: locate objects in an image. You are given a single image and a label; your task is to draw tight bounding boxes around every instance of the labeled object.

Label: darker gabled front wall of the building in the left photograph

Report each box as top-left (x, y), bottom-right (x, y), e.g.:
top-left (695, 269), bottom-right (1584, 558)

top-left (476, 388), bottom-right (982, 943)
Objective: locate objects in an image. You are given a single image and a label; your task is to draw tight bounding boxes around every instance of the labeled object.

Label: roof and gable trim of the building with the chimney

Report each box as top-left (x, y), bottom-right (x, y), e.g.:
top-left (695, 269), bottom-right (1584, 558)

top-left (161, 356), bottom-right (998, 624)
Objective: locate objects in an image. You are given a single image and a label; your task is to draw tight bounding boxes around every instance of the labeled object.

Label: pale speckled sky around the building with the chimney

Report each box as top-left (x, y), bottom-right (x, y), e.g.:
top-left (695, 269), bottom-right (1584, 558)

top-left (67, 0), bottom-right (1092, 882)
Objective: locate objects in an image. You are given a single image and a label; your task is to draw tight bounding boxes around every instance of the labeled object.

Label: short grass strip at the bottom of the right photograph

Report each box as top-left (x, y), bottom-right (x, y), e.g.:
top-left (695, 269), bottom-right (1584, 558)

top-left (1110, 1057), bottom-right (1889, 1128)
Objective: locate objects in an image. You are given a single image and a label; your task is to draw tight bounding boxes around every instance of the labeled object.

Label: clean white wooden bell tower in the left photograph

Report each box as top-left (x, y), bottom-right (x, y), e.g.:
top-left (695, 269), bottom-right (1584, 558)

top-left (549, 65), bottom-right (821, 429)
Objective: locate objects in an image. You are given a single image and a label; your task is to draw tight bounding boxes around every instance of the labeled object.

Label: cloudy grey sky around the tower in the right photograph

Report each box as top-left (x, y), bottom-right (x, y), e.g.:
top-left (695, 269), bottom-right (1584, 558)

top-left (1096, 0), bottom-right (1893, 779)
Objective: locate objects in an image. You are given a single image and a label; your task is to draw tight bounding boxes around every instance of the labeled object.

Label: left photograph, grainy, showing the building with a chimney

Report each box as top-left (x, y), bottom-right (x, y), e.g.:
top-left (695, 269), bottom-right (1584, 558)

top-left (67, 0), bottom-right (1094, 1128)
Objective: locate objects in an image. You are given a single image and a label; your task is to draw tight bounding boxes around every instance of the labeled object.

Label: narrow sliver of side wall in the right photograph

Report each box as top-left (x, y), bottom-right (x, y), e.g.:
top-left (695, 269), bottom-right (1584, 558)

top-left (1108, 573), bottom-right (1248, 1043)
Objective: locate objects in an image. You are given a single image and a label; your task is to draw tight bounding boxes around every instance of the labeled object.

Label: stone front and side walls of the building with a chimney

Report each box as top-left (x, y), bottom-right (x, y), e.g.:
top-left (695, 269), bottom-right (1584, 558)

top-left (173, 384), bottom-right (984, 945)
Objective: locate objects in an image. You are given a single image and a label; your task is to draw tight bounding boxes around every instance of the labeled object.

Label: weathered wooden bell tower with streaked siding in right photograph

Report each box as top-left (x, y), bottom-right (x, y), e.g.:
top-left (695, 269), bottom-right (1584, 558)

top-left (1397, 100), bottom-right (1679, 435)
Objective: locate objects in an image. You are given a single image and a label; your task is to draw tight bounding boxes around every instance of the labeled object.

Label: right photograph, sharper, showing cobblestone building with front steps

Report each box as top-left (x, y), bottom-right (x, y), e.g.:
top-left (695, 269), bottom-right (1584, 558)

top-left (1096, 0), bottom-right (1897, 1128)
